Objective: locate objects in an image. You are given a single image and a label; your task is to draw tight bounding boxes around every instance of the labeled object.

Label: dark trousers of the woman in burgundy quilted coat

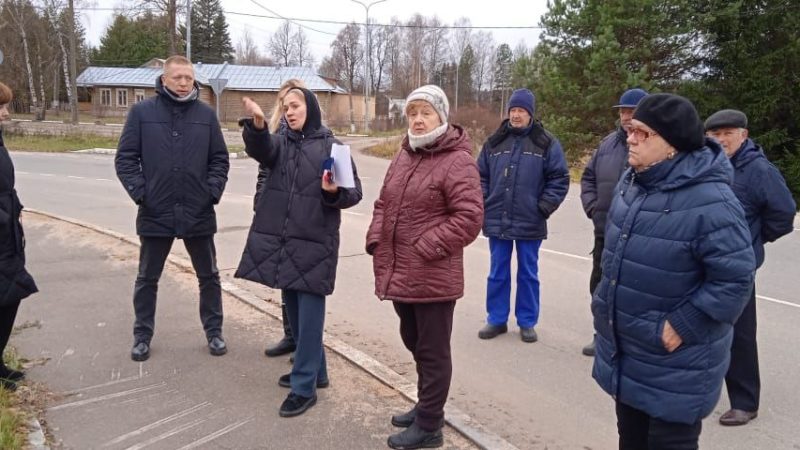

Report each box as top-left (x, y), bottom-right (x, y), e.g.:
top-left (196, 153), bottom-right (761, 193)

top-left (394, 301), bottom-right (456, 431)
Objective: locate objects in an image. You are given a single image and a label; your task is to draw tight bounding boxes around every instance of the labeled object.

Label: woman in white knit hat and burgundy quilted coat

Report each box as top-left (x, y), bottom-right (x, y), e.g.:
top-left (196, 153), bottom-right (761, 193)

top-left (366, 85), bottom-right (483, 449)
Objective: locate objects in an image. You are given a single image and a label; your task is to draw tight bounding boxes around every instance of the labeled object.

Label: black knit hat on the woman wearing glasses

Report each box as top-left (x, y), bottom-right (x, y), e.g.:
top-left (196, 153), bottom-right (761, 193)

top-left (633, 94), bottom-right (705, 152)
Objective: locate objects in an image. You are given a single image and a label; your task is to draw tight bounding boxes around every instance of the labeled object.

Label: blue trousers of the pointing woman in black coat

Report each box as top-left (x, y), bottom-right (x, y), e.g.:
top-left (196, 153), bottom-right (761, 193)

top-left (281, 289), bottom-right (328, 397)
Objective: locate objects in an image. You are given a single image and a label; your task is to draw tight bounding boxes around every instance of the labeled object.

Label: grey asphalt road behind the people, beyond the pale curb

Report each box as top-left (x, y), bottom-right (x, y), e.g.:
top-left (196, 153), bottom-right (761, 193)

top-left (12, 141), bottom-right (800, 449)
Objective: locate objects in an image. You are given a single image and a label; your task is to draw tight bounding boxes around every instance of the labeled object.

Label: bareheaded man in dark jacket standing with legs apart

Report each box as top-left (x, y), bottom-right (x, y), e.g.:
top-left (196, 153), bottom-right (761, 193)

top-left (115, 56), bottom-right (229, 361)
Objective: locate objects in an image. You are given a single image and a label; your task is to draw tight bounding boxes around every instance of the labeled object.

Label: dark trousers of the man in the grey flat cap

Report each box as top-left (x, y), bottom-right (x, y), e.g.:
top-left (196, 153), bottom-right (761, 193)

top-left (725, 284), bottom-right (761, 411)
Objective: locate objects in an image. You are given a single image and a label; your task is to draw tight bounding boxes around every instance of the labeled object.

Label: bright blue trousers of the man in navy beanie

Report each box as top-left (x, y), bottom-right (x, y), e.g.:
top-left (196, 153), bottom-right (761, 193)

top-left (486, 238), bottom-right (542, 328)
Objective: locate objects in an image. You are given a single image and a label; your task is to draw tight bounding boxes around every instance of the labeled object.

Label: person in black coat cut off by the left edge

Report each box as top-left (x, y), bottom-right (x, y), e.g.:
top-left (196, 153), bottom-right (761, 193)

top-left (0, 83), bottom-right (38, 390)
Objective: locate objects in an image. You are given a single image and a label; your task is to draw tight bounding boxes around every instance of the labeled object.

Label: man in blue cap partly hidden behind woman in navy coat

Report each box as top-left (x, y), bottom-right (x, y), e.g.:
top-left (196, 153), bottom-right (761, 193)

top-left (581, 89), bottom-right (647, 356)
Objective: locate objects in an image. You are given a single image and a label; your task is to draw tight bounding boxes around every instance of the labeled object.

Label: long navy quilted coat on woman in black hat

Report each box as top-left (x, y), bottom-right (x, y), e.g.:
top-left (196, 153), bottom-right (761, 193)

top-left (592, 140), bottom-right (756, 424)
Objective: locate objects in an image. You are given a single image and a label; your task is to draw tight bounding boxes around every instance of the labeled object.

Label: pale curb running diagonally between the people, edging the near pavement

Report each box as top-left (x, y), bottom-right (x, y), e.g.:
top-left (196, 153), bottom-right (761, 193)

top-left (25, 208), bottom-right (519, 450)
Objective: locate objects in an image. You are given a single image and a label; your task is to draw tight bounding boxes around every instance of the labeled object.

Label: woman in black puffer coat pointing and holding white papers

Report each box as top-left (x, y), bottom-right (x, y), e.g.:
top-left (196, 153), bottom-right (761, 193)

top-left (236, 88), bottom-right (362, 417)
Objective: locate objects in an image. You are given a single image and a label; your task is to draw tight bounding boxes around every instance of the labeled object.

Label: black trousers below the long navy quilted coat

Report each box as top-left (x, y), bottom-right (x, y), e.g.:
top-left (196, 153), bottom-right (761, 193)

top-left (617, 402), bottom-right (703, 450)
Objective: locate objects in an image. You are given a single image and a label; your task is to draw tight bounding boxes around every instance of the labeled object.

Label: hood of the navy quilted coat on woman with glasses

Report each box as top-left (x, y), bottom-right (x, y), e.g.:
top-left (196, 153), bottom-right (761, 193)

top-left (626, 138), bottom-right (733, 191)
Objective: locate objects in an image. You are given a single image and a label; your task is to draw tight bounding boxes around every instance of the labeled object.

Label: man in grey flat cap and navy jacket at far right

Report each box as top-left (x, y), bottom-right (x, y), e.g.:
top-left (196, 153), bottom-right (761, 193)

top-left (705, 109), bottom-right (796, 426)
